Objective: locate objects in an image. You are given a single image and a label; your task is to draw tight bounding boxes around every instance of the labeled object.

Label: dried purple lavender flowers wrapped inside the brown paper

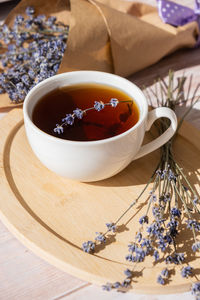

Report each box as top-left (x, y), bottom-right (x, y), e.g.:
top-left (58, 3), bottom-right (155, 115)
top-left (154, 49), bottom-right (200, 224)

top-left (0, 7), bottom-right (69, 103)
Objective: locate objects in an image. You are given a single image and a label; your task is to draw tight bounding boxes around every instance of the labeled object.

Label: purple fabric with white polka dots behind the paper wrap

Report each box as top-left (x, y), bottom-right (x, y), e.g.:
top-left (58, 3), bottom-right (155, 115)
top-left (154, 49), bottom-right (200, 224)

top-left (157, 0), bottom-right (200, 47)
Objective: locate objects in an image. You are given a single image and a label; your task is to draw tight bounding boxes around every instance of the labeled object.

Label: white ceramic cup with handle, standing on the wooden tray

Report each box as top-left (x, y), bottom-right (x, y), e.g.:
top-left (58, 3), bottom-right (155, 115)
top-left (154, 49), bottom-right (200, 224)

top-left (23, 71), bottom-right (177, 182)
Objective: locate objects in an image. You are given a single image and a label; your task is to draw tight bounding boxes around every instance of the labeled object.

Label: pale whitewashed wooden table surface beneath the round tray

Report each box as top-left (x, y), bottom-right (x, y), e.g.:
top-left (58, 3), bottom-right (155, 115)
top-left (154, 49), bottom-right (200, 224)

top-left (0, 0), bottom-right (200, 300)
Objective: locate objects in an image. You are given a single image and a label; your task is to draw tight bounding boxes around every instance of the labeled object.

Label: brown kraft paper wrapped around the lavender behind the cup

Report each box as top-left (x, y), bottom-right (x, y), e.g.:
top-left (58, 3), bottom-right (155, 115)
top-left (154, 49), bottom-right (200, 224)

top-left (0, 0), bottom-right (199, 107)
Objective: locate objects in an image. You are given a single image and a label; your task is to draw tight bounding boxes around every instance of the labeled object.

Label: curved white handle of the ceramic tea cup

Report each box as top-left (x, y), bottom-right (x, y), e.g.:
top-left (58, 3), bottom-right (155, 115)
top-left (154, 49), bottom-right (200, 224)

top-left (133, 107), bottom-right (177, 160)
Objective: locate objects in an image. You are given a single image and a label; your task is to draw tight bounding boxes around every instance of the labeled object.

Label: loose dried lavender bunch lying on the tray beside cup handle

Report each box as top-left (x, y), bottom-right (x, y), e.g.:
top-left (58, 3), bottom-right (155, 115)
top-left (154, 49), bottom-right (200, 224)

top-left (82, 71), bottom-right (200, 299)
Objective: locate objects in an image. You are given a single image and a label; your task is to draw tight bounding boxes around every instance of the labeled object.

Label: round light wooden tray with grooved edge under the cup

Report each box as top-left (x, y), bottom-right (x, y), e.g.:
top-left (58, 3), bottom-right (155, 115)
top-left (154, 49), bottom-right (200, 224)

top-left (0, 109), bottom-right (200, 294)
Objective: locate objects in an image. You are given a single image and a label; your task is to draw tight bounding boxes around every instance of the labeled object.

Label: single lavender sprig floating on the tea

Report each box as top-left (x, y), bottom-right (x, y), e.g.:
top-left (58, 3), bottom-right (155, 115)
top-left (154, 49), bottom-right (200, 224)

top-left (54, 98), bottom-right (133, 134)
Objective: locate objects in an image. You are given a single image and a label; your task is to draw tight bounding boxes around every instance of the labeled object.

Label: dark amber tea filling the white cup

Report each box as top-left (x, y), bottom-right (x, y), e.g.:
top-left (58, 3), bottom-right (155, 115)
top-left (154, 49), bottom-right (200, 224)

top-left (32, 83), bottom-right (139, 141)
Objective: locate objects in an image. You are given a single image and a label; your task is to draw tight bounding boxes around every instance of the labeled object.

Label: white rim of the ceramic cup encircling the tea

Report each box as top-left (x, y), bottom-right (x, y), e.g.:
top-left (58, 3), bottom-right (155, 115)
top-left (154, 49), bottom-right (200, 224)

top-left (23, 70), bottom-right (148, 146)
